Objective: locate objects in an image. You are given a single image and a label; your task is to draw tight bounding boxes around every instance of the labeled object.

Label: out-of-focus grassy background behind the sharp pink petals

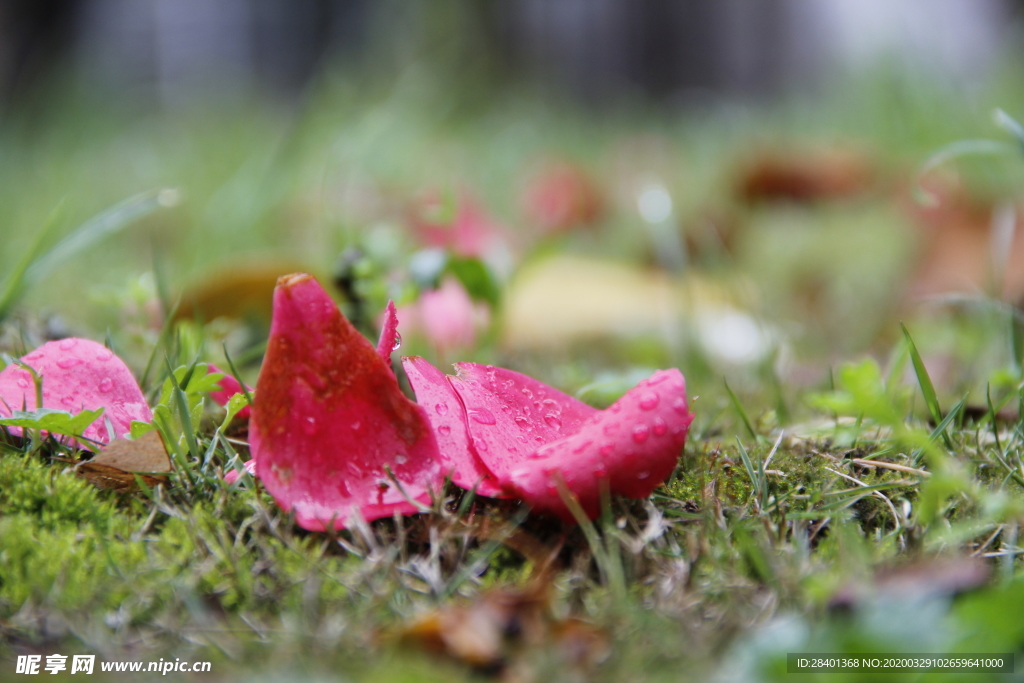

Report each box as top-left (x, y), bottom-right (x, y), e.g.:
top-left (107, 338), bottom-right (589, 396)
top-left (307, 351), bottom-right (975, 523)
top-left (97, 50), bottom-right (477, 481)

top-left (0, 0), bottom-right (1024, 421)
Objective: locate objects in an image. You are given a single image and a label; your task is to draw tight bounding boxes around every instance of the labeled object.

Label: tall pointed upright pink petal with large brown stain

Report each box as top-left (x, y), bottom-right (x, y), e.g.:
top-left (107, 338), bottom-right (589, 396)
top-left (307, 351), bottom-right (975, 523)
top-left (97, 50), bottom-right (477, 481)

top-left (249, 273), bottom-right (443, 530)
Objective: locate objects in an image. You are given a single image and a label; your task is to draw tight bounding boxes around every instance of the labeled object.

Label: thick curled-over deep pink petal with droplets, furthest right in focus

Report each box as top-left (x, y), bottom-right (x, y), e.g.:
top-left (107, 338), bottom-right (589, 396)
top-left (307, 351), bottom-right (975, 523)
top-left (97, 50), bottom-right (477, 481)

top-left (508, 370), bottom-right (693, 521)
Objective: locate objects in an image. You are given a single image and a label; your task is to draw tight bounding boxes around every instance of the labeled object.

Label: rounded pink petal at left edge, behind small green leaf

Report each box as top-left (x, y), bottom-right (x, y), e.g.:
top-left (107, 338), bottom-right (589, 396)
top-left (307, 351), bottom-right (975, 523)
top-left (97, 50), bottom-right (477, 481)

top-left (0, 337), bottom-right (153, 443)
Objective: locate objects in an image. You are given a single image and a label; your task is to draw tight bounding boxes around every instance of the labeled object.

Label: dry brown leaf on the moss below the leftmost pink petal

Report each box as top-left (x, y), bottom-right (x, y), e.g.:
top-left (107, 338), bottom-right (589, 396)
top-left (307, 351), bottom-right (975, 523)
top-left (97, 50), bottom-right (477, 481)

top-left (76, 430), bottom-right (171, 490)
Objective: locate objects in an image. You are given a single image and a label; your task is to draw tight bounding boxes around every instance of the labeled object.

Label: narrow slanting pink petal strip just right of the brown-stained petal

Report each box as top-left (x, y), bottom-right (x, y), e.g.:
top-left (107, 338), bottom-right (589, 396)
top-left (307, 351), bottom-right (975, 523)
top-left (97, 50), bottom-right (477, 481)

top-left (401, 356), bottom-right (508, 498)
